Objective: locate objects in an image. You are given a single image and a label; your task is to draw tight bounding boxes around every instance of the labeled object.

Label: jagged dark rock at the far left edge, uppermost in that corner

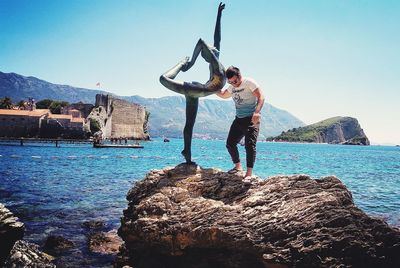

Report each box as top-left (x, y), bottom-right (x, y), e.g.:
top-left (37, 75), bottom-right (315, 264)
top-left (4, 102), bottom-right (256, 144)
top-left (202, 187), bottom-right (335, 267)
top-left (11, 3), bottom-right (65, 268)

top-left (0, 203), bottom-right (25, 266)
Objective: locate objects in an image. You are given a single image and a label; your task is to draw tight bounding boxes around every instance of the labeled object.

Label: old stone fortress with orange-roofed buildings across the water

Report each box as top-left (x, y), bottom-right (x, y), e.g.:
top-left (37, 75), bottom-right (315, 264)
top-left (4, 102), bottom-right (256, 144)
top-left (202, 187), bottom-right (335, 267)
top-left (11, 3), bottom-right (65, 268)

top-left (0, 94), bottom-right (149, 140)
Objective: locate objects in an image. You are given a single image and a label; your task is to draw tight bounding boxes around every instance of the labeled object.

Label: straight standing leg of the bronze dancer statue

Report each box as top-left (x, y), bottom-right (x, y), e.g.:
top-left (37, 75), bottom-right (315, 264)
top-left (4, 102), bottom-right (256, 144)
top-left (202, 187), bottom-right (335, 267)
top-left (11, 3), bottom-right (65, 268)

top-left (182, 96), bottom-right (199, 165)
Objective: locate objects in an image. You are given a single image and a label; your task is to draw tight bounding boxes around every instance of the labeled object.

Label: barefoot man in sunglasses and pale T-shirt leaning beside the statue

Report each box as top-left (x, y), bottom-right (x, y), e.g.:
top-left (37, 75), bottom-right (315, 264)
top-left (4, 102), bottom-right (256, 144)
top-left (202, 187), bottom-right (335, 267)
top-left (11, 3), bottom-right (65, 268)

top-left (216, 66), bottom-right (264, 182)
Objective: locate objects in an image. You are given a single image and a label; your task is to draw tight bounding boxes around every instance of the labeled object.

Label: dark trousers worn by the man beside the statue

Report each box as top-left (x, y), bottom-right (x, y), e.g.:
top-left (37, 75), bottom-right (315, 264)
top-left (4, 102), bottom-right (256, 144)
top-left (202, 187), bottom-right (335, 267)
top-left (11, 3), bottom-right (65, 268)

top-left (226, 116), bottom-right (260, 168)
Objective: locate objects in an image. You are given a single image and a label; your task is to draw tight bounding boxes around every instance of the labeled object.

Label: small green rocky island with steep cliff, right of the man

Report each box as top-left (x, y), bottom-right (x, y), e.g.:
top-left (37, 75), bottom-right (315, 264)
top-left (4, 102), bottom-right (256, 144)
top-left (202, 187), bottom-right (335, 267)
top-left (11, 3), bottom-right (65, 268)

top-left (268, 116), bottom-right (370, 145)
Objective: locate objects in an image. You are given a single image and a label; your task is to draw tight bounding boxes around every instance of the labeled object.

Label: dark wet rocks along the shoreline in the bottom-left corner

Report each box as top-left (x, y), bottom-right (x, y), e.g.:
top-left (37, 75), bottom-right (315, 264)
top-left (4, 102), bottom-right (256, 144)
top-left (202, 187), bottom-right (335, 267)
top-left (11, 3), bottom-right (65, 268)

top-left (0, 203), bottom-right (122, 268)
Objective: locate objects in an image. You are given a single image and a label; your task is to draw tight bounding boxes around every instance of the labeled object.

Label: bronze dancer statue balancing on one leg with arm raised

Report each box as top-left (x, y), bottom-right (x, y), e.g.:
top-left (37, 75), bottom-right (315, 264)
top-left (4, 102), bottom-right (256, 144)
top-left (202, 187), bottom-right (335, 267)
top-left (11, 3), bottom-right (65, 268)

top-left (160, 3), bottom-right (226, 164)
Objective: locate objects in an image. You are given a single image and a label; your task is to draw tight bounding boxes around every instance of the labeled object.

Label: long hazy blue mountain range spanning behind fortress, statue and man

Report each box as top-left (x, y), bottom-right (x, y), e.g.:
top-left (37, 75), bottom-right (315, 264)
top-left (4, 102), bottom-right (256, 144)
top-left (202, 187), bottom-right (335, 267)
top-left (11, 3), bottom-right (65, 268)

top-left (0, 72), bottom-right (305, 138)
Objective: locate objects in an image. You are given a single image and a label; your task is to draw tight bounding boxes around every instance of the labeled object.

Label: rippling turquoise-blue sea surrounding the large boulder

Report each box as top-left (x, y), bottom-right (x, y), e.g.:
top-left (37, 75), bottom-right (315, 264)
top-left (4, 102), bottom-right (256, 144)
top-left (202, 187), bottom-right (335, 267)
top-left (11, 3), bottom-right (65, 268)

top-left (0, 139), bottom-right (400, 267)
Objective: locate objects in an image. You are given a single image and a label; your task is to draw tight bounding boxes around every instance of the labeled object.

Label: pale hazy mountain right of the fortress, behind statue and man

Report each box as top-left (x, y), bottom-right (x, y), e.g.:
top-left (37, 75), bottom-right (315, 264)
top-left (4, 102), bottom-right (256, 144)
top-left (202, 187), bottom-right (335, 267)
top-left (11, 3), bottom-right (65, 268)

top-left (126, 96), bottom-right (305, 138)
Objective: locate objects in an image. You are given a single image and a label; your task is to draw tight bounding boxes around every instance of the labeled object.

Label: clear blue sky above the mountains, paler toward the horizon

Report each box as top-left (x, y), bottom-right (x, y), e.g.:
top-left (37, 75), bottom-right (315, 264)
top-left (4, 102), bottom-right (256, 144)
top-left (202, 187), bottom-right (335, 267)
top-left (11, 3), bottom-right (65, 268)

top-left (0, 0), bottom-right (400, 144)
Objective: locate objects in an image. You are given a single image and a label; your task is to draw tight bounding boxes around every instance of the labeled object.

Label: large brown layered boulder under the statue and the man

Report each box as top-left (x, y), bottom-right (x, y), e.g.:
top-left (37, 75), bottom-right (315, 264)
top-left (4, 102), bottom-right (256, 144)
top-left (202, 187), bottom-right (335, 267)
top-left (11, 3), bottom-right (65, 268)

top-left (117, 165), bottom-right (400, 268)
